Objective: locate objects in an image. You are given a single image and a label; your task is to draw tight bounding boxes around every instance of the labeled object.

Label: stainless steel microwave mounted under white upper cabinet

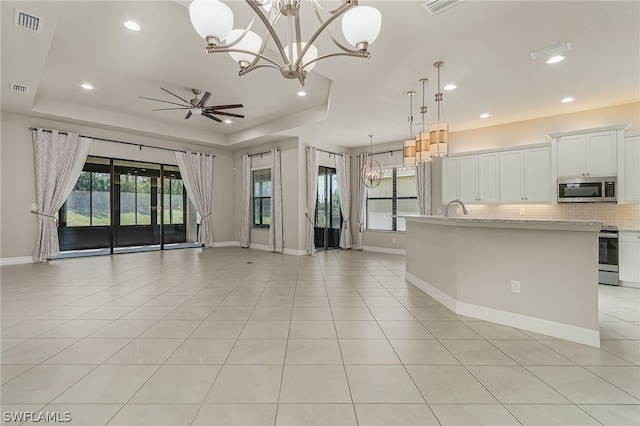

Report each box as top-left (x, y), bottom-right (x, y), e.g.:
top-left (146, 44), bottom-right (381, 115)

top-left (558, 177), bottom-right (618, 203)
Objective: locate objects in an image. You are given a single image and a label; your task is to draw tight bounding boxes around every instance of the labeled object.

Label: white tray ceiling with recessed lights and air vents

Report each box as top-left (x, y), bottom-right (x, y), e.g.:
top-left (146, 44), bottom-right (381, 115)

top-left (1, 0), bottom-right (640, 149)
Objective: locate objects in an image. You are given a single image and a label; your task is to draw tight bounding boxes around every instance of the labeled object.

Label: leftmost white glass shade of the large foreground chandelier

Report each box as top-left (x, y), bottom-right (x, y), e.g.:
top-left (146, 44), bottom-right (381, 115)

top-left (189, 0), bottom-right (233, 40)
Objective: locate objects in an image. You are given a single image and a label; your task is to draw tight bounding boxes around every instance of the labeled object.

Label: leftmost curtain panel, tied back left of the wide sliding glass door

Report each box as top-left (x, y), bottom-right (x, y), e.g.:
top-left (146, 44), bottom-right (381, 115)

top-left (32, 129), bottom-right (91, 262)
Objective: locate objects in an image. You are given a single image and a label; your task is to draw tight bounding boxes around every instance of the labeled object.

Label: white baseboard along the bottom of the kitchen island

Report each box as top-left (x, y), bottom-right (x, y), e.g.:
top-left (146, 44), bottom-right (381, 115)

top-left (405, 272), bottom-right (600, 348)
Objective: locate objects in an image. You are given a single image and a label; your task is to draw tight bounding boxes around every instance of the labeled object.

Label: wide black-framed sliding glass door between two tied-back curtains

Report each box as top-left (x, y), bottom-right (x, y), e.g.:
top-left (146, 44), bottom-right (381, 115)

top-left (58, 157), bottom-right (190, 253)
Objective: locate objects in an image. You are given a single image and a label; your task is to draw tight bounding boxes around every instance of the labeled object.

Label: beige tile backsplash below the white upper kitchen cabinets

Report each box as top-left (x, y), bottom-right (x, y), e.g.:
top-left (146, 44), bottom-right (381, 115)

top-left (460, 203), bottom-right (640, 230)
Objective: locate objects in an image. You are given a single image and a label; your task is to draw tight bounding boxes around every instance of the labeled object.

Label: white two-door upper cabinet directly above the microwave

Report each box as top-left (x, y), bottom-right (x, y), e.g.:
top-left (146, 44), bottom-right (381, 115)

top-left (558, 130), bottom-right (618, 177)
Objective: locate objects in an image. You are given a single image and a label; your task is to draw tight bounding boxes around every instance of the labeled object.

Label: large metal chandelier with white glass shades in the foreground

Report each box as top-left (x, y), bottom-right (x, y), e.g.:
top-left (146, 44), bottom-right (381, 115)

top-left (189, 0), bottom-right (382, 85)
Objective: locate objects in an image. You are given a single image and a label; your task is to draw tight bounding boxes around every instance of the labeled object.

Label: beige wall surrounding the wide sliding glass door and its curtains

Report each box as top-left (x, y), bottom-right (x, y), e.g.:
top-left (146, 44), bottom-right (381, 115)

top-left (0, 114), bottom-right (237, 259)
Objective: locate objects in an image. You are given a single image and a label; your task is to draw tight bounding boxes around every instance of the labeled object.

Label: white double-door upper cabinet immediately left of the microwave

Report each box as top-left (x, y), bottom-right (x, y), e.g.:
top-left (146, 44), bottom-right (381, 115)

top-left (500, 146), bottom-right (552, 204)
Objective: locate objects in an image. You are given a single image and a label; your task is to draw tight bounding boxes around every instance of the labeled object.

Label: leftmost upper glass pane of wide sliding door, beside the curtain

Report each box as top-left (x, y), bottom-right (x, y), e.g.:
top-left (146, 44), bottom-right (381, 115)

top-left (61, 170), bottom-right (111, 226)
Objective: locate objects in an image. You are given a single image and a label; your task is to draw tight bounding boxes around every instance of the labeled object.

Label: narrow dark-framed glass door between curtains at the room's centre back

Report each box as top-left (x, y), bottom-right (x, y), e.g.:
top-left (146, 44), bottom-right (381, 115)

top-left (314, 167), bottom-right (342, 250)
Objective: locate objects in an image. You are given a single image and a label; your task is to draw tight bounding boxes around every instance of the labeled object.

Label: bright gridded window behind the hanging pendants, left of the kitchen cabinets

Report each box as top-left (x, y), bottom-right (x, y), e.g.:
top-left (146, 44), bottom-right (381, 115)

top-left (367, 167), bottom-right (419, 231)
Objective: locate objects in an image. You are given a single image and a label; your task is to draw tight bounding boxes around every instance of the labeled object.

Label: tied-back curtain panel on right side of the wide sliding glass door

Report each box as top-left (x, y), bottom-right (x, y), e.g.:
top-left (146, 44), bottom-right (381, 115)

top-left (176, 152), bottom-right (213, 247)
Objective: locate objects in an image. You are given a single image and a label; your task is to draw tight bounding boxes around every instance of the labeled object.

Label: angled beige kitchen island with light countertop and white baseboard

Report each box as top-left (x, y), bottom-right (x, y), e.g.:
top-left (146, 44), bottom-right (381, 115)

top-left (403, 216), bottom-right (602, 347)
